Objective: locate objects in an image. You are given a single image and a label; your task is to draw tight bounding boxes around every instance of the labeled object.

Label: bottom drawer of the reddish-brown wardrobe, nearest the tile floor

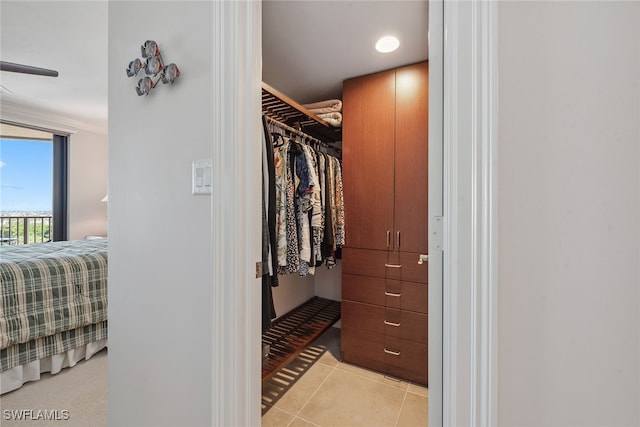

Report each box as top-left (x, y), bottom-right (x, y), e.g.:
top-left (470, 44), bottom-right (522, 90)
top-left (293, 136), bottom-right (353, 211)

top-left (341, 324), bottom-right (428, 385)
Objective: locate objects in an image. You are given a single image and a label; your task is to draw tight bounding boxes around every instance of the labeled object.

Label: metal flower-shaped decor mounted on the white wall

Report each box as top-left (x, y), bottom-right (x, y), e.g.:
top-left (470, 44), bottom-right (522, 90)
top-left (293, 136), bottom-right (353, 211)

top-left (127, 40), bottom-right (180, 96)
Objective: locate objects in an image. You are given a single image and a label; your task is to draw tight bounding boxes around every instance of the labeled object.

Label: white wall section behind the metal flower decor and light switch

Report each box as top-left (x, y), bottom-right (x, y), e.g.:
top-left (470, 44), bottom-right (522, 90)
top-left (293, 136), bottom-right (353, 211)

top-left (108, 1), bottom-right (214, 427)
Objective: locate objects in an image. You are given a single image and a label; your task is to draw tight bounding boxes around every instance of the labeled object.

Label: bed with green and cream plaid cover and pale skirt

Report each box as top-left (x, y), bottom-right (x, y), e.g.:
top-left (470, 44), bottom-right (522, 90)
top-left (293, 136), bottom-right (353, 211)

top-left (0, 239), bottom-right (108, 394)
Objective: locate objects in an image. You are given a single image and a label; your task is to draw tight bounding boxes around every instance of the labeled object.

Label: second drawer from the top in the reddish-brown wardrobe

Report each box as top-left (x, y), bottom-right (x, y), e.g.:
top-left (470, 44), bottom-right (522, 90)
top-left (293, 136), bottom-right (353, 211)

top-left (342, 273), bottom-right (429, 314)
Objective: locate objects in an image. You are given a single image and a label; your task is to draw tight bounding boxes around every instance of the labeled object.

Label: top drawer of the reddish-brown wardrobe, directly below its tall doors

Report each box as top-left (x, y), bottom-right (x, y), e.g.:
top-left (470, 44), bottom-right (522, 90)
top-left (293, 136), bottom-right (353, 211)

top-left (342, 248), bottom-right (428, 283)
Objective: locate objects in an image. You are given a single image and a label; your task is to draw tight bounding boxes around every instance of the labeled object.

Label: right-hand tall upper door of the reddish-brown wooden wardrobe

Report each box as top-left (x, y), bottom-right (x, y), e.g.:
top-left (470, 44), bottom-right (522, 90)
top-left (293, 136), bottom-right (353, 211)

top-left (394, 62), bottom-right (429, 254)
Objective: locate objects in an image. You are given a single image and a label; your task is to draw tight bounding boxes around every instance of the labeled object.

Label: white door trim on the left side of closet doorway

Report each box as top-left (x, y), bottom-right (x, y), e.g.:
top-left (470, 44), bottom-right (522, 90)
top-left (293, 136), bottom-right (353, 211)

top-left (210, 1), bottom-right (262, 426)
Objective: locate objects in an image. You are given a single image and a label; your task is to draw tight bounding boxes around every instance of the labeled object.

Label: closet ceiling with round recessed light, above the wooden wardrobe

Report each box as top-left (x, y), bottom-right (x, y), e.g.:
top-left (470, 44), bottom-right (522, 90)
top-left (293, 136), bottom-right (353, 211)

top-left (262, 0), bottom-right (429, 104)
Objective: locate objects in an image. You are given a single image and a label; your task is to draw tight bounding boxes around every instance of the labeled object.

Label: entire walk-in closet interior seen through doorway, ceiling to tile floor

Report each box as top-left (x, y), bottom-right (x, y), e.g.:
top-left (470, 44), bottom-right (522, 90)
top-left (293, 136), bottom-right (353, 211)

top-left (260, 1), bottom-right (429, 426)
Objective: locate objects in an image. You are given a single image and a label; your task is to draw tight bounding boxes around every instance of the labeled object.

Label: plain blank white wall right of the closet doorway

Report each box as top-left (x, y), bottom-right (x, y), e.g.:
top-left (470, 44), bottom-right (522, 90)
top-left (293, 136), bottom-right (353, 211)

top-left (498, 2), bottom-right (640, 427)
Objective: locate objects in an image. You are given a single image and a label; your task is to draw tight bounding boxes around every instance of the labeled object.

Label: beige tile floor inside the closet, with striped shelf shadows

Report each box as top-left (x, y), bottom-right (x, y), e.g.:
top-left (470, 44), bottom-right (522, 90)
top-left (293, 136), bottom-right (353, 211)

top-left (262, 328), bottom-right (428, 427)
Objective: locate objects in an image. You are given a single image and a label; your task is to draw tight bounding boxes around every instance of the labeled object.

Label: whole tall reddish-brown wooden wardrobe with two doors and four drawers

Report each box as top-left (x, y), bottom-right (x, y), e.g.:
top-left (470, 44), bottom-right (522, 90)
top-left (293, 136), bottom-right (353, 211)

top-left (341, 62), bottom-right (428, 385)
